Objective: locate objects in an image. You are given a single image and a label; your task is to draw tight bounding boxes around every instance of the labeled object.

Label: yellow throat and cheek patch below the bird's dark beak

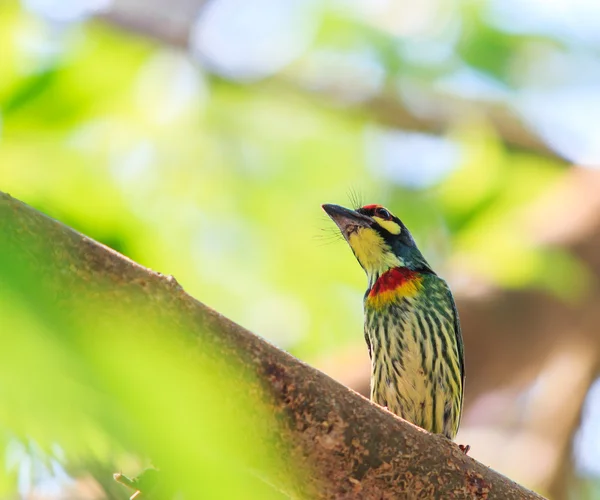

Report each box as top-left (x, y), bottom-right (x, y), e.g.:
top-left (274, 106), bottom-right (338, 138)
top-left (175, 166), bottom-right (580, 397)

top-left (348, 227), bottom-right (404, 274)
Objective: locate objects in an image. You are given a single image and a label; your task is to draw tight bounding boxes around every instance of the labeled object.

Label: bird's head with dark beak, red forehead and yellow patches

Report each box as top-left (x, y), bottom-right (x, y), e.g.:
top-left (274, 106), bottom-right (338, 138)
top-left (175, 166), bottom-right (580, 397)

top-left (323, 204), bottom-right (432, 281)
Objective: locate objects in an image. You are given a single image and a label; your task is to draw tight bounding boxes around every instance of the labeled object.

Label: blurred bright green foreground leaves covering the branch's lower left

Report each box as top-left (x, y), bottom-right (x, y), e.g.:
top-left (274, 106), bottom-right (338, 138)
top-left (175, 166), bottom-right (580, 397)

top-left (0, 205), bottom-right (288, 499)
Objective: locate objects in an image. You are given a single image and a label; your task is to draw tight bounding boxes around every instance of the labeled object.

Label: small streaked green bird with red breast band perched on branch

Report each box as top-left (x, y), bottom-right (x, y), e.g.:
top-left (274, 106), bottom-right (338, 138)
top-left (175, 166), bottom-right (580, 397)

top-left (322, 204), bottom-right (469, 444)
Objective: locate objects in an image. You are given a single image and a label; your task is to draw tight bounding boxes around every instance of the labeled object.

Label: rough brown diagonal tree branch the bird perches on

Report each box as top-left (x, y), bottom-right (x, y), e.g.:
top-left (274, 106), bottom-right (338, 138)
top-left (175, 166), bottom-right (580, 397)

top-left (0, 193), bottom-right (541, 500)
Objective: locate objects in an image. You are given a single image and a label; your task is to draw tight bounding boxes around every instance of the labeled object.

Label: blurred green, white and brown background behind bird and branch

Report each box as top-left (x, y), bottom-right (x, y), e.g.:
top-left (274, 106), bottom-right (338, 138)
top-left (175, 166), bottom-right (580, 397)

top-left (0, 0), bottom-right (600, 500)
